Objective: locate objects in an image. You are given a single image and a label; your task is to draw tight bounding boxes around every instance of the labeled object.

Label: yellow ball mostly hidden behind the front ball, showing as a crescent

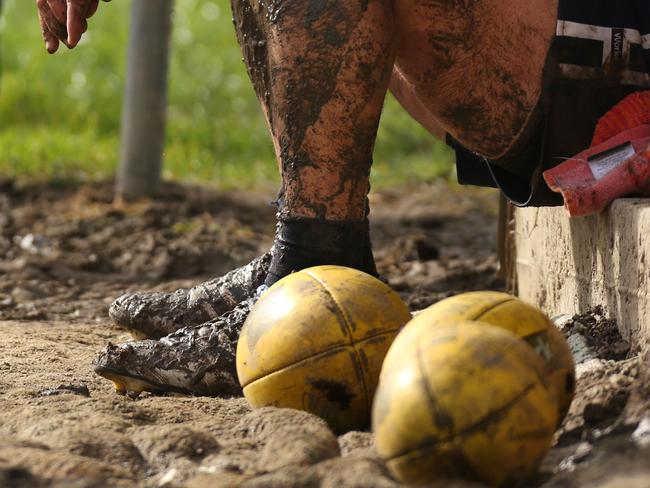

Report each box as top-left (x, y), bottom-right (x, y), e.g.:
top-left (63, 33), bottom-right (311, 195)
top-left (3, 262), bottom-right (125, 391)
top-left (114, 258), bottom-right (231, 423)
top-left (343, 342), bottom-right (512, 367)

top-left (385, 291), bottom-right (575, 423)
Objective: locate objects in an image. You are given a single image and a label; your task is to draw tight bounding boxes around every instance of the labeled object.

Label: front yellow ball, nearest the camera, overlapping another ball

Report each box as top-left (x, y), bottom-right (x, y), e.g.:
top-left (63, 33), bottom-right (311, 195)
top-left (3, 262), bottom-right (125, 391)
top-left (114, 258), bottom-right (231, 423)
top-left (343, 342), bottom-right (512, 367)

top-left (372, 321), bottom-right (557, 486)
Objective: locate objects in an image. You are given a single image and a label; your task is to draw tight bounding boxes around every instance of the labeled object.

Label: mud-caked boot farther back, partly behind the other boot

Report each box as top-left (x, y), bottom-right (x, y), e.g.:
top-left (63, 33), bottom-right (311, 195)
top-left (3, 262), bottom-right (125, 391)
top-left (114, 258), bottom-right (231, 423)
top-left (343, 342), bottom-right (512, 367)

top-left (108, 252), bottom-right (271, 339)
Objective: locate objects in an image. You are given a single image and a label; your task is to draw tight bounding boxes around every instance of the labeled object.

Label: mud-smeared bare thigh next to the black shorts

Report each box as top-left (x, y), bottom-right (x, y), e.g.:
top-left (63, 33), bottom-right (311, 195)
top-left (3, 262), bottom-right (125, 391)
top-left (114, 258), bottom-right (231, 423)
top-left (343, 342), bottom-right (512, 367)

top-left (391, 0), bottom-right (557, 160)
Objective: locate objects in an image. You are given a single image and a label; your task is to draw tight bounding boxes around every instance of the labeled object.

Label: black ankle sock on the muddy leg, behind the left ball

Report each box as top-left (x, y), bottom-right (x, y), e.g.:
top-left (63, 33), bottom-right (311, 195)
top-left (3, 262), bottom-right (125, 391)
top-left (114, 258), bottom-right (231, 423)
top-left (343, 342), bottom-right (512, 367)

top-left (265, 217), bottom-right (377, 286)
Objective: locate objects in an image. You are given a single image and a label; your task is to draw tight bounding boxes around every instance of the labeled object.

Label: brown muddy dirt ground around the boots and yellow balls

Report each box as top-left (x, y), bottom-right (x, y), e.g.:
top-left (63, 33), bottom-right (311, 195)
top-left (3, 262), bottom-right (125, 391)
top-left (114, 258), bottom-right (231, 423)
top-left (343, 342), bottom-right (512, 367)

top-left (0, 182), bottom-right (650, 488)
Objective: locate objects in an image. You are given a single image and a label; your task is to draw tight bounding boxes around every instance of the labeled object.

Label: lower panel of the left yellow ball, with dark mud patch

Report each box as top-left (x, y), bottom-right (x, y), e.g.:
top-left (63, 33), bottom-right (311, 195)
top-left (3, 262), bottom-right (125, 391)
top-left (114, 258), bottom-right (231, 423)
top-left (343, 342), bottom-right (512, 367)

top-left (244, 346), bottom-right (368, 432)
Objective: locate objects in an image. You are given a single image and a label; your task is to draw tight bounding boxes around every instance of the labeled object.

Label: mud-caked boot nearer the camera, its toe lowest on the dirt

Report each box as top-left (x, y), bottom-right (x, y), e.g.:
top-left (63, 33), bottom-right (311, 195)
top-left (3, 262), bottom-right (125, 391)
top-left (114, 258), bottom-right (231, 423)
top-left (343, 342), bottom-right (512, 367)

top-left (94, 297), bottom-right (256, 397)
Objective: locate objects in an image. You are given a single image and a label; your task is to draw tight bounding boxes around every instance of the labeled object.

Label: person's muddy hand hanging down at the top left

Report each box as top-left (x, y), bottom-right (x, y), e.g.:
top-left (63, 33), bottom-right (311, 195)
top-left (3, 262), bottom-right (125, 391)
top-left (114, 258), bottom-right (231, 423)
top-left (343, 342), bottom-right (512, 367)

top-left (36, 0), bottom-right (110, 54)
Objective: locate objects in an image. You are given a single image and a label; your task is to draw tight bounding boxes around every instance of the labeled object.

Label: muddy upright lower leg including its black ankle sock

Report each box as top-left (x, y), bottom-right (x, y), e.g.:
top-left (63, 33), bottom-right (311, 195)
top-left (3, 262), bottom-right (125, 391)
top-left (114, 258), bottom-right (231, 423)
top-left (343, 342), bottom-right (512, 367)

top-left (232, 0), bottom-right (395, 284)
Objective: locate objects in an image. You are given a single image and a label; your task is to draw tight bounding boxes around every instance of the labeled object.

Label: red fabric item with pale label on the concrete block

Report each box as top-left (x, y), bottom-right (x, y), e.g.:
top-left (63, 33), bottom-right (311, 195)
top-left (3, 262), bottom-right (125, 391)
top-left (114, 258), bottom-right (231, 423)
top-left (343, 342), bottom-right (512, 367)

top-left (544, 91), bottom-right (650, 217)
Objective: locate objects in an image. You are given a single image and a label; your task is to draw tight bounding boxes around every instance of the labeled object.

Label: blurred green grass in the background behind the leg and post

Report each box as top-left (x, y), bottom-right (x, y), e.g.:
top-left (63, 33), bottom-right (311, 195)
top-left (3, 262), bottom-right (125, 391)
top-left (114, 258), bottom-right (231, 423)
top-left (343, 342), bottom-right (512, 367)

top-left (0, 0), bottom-right (451, 187)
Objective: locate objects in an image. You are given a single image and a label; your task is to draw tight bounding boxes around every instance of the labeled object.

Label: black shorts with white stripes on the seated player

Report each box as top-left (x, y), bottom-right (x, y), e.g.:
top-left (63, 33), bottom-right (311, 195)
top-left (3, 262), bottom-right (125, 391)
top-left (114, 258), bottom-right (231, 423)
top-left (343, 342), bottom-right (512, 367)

top-left (447, 0), bottom-right (650, 206)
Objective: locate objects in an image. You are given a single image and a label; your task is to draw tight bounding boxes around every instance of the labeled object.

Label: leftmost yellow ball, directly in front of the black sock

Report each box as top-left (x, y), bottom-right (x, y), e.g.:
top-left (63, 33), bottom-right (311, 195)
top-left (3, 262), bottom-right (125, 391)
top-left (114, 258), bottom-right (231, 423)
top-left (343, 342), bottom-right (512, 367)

top-left (237, 266), bottom-right (411, 432)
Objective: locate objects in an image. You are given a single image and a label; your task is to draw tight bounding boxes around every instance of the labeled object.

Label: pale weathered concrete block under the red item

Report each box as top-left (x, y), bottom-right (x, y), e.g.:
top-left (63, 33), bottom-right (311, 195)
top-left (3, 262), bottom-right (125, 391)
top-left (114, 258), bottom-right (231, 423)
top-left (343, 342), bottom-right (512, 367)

top-left (515, 198), bottom-right (650, 349)
